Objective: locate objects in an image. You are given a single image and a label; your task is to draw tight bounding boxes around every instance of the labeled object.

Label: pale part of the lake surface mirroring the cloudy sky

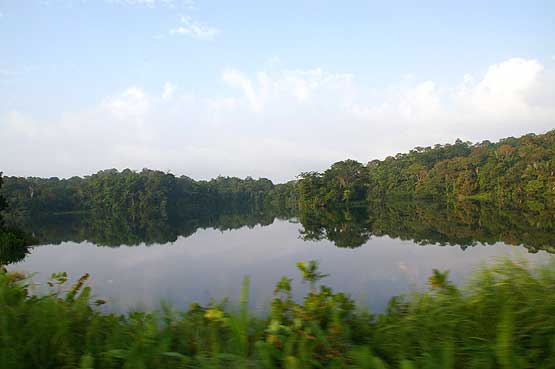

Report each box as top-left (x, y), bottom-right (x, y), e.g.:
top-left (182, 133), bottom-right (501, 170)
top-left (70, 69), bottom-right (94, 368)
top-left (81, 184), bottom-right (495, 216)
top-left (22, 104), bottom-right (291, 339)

top-left (9, 207), bottom-right (554, 312)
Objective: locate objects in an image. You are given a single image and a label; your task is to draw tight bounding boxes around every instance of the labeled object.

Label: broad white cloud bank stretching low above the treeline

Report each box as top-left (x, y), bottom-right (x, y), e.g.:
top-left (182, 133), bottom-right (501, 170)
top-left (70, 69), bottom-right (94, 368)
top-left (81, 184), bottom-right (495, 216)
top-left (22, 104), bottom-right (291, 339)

top-left (0, 59), bottom-right (555, 180)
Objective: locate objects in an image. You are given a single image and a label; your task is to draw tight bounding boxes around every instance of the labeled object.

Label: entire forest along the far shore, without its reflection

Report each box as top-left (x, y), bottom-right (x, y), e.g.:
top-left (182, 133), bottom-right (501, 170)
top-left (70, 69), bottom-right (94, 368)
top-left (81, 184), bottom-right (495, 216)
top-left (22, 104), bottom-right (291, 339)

top-left (2, 130), bottom-right (555, 219)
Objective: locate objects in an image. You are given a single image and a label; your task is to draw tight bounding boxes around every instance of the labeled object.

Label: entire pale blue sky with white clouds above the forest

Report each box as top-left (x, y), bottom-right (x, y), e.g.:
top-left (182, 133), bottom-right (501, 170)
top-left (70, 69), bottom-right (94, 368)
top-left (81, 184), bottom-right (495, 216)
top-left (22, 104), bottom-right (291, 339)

top-left (0, 0), bottom-right (555, 182)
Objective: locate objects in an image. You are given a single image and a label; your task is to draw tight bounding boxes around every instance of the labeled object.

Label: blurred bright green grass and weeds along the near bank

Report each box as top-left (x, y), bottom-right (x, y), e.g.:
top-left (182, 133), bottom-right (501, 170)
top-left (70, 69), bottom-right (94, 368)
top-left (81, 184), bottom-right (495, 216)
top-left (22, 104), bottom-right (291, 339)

top-left (0, 259), bottom-right (555, 369)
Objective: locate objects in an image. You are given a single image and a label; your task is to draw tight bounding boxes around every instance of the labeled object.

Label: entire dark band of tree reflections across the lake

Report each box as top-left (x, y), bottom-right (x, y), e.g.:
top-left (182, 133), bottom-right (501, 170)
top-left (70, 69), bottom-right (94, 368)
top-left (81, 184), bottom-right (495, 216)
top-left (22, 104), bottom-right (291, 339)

top-left (5, 201), bottom-right (555, 264)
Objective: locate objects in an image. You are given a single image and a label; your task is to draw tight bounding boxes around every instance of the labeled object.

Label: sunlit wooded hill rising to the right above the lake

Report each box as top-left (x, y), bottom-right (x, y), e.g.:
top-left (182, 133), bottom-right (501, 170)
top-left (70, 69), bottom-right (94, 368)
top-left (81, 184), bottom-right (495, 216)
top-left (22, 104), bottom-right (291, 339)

top-left (298, 130), bottom-right (555, 207)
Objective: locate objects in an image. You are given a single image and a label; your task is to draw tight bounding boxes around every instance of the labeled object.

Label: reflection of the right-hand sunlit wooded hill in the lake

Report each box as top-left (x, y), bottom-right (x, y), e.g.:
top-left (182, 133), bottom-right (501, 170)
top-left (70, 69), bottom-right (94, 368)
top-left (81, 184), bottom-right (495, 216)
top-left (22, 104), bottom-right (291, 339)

top-left (299, 201), bottom-right (555, 252)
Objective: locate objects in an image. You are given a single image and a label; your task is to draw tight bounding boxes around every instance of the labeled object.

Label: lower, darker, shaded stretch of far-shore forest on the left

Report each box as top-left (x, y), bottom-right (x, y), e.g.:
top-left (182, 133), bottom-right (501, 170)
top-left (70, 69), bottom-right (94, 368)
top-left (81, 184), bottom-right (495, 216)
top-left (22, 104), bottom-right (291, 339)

top-left (2, 169), bottom-right (295, 218)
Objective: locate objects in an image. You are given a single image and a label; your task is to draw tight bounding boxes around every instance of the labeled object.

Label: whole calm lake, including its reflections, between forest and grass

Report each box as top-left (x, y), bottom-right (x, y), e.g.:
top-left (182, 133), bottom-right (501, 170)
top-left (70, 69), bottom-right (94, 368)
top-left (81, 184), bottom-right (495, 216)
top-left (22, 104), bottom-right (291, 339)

top-left (8, 203), bottom-right (555, 312)
